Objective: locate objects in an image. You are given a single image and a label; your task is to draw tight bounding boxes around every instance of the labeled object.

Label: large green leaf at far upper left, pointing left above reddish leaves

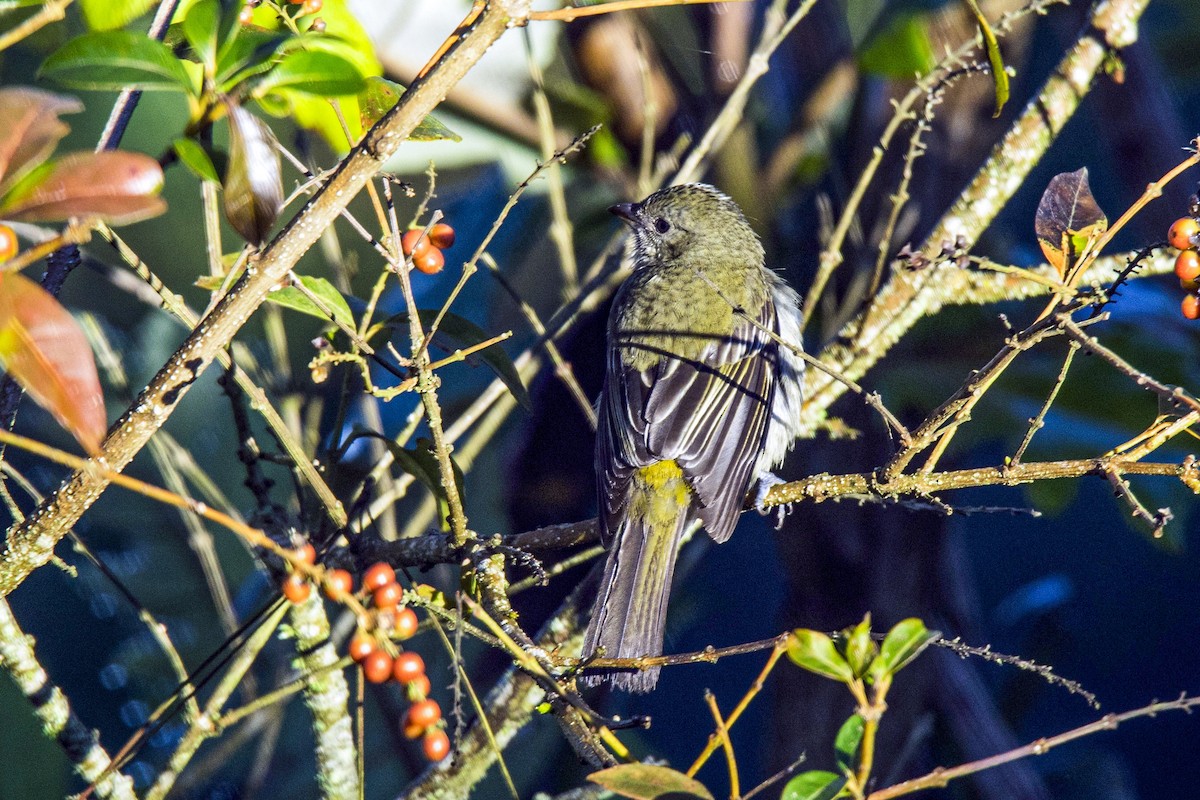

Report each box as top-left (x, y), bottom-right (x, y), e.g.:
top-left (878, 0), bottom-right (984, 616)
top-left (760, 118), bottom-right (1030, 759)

top-left (40, 30), bottom-right (194, 92)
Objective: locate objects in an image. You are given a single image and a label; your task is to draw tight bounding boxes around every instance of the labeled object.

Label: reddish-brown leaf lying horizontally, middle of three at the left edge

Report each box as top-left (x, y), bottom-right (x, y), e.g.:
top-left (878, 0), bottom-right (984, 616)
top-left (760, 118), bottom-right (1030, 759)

top-left (0, 151), bottom-right (167, 225)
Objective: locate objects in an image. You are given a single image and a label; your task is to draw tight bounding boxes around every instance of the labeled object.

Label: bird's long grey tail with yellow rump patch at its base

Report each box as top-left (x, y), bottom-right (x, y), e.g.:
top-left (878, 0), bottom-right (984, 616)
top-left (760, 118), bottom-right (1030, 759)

top-left (580, 462), bottom-right (690, 692)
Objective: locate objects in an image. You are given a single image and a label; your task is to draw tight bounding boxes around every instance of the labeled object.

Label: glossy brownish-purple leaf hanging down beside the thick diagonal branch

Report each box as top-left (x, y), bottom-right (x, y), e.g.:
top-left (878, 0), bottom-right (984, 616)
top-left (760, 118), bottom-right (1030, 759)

top-left (223, 103), bottom-right (283, 245)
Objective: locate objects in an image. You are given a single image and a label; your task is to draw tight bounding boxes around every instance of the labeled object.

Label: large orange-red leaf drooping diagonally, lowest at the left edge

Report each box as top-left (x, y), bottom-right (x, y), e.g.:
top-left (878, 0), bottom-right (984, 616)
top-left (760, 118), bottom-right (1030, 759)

top-left (0, 272), bottom-right (107, 453)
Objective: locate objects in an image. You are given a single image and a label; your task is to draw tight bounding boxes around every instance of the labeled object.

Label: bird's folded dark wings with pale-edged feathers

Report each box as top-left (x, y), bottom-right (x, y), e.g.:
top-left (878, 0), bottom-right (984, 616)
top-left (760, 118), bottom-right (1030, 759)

top-left (596, 302), bottom-right (778, 542)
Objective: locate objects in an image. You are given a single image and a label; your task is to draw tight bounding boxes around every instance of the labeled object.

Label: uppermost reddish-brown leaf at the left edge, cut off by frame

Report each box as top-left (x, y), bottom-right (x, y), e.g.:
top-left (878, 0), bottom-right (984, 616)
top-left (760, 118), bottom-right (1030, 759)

top-left (0, 89), bottom-right (83, 192)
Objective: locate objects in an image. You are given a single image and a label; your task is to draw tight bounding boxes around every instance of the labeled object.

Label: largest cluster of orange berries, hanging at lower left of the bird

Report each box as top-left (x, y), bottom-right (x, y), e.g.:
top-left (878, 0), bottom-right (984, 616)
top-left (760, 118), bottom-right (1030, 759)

top-left (276, 545), bottom-right (450, 762)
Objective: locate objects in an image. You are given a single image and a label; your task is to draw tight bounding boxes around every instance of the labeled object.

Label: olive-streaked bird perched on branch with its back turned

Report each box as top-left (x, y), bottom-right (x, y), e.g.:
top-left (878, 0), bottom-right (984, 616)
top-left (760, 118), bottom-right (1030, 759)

top-left (580, 184), bottom-right (804, 692)
